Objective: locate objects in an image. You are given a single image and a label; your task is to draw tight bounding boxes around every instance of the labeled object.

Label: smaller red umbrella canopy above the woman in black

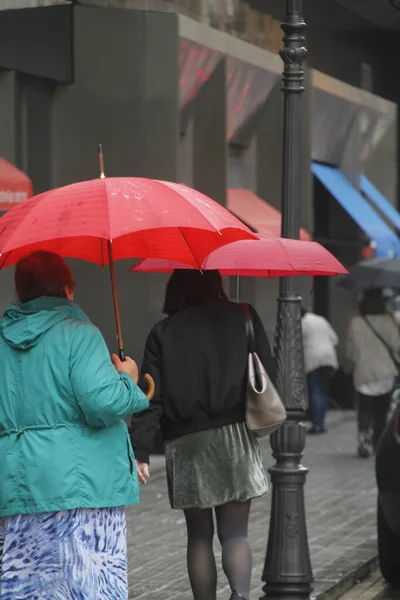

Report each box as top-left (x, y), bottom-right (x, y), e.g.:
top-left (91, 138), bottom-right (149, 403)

top-left (131, 238), bottom-right (347, 277)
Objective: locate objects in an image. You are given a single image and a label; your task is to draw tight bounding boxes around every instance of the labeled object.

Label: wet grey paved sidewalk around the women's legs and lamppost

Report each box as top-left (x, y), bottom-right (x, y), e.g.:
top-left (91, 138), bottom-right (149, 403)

top-left (127, 412), bottom-right (376, 600)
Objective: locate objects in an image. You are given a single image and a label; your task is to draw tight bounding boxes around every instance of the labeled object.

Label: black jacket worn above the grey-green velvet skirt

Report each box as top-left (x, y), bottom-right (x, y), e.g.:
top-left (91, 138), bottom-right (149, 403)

top-left (131, 301), bottom-right (275, 462)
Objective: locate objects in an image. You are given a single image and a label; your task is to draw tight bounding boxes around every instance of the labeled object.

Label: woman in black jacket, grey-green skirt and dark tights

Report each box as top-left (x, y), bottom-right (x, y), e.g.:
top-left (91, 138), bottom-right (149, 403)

top-left (131, 270), bottom-right (275, 600)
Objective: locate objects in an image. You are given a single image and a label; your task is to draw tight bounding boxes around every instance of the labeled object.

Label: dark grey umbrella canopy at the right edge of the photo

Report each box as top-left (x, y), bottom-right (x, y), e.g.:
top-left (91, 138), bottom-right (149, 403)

top-left (339, 258), bottom-right (400, 292)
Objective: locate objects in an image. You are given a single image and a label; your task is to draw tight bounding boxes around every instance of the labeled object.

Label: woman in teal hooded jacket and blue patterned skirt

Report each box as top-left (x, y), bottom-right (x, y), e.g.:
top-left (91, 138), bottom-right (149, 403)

top-left (0, 251), bottom-right (148, 600)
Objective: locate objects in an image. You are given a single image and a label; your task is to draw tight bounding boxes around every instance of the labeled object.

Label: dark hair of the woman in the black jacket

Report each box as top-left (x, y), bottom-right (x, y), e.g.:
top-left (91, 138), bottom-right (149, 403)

top-left (163, 269), bottom-right (228, 315)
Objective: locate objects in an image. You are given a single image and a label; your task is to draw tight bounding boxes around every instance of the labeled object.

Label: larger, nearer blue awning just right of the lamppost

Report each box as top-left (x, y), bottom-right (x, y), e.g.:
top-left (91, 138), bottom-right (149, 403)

top-left (312, 163), bottom-right (400, 257)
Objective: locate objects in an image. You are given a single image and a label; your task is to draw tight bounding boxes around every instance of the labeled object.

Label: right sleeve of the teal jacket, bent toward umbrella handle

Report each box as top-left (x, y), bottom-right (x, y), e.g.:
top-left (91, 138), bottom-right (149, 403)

top-left (70, 324), bottom-right (149, 427)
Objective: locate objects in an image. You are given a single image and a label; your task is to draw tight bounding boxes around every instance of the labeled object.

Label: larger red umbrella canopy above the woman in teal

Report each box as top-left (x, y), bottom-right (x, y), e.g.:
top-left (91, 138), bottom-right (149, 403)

top-left (0, 177), bottom-right (256, 268)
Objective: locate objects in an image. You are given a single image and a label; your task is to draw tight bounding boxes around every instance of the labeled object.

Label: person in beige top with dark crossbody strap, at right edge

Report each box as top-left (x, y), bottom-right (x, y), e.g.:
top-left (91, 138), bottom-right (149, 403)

top-left (346, 290), bottom-right (400, 458)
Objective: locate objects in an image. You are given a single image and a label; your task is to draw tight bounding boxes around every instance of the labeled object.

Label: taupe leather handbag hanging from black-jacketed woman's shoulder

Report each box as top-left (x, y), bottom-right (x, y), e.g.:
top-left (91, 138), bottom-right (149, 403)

top-left (242, 304), bottom-right (286, 438)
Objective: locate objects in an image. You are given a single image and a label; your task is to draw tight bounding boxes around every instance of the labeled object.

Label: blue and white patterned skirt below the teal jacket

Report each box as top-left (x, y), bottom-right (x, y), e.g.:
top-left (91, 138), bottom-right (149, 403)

top-left (0, 507), bottom-right (128, 600)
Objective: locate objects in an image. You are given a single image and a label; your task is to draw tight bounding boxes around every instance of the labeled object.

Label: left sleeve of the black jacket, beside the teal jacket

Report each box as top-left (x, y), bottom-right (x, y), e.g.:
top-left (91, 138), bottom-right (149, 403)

top-left (130, 329), bottom-right (163, 463)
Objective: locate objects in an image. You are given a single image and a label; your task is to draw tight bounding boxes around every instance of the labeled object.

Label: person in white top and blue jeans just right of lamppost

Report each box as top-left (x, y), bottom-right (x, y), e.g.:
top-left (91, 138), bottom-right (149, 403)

top-left (301, 307), bottom-right (339, 434)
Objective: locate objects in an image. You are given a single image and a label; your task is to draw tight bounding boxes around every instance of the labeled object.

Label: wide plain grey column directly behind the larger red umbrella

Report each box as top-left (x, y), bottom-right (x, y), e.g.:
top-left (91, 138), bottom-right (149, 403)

top-left (52, 6), bottom-right (179, 361)
